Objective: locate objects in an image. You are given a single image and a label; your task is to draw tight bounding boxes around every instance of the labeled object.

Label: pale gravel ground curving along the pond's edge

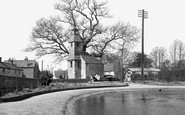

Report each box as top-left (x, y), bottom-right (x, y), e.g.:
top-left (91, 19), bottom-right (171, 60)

top-left (0, 83), bottom-right (185, 115)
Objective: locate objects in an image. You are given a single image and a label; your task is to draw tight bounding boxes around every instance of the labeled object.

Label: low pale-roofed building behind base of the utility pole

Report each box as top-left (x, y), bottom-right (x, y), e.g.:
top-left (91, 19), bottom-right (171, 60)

top-left (125, 68), bottom-right (160, 81)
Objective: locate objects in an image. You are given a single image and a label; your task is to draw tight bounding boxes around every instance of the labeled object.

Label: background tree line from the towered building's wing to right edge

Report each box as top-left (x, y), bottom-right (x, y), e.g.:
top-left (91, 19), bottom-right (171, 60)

top-left (104, 39), bottom-right (185, 70)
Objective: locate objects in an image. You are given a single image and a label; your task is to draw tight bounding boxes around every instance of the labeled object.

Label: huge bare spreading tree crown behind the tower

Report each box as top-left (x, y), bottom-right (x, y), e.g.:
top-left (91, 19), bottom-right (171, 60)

top-left (25, 0), bottom-right (140, 61)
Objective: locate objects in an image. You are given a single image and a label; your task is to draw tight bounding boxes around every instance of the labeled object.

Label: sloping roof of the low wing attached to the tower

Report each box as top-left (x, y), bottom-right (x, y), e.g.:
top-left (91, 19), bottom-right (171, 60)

top-left (81, 55), bottom-right (103, 64)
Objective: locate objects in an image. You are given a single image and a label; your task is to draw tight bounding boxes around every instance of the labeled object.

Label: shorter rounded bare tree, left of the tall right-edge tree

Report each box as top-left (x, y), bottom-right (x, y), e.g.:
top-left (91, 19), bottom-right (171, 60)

top-left (150, 47), bottom-right (167, 68)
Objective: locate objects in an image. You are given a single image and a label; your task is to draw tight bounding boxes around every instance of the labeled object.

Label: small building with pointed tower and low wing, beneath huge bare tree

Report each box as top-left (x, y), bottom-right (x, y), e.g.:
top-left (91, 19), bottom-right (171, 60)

top-left (67, 29), bottom-right (104, 79)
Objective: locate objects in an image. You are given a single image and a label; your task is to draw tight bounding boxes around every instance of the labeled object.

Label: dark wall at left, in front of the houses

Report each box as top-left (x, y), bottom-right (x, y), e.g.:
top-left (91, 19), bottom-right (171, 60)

top-left (0, 76), bottom-right (40, 96)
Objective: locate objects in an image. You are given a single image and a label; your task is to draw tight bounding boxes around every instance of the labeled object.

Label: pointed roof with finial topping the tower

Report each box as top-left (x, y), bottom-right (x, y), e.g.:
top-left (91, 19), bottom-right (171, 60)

top-left (68, 28), bottom-right (82, 43)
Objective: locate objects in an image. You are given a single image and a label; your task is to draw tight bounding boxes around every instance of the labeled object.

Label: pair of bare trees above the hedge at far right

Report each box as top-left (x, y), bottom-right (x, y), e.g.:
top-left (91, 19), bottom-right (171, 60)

top-left (150, 39), bottom-right (185, 69)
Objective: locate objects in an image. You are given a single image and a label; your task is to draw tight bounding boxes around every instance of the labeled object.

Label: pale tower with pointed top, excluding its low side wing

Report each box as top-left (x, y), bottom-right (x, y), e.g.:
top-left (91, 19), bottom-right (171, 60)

top-left (67, 28), bottom-right (82, 79)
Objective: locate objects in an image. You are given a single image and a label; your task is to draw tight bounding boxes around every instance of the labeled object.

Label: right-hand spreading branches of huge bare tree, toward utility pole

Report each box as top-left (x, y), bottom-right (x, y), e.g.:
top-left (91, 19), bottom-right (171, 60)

top-left (89, 22), bottom-right (139, 57)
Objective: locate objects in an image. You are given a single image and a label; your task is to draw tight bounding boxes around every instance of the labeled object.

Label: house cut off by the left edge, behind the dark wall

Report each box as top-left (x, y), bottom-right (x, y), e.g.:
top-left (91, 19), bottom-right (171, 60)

top-left (0, 57), bottom-right (23, 77)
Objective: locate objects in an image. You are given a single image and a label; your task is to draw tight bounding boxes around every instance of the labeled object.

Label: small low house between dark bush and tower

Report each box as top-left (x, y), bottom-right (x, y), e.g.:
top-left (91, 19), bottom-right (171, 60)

top-left (53, 70), bottom-right (68, 79)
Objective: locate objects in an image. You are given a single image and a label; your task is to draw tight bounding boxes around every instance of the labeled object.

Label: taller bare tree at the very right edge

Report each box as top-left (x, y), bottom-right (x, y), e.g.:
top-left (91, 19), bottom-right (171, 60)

top-left (170, 39), bottom-right (185, 67)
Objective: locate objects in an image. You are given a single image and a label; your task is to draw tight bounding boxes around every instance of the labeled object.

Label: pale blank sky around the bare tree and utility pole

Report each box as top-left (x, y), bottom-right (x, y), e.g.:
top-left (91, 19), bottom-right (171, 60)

top-left (0, 0), bottom-right (185, 69)
